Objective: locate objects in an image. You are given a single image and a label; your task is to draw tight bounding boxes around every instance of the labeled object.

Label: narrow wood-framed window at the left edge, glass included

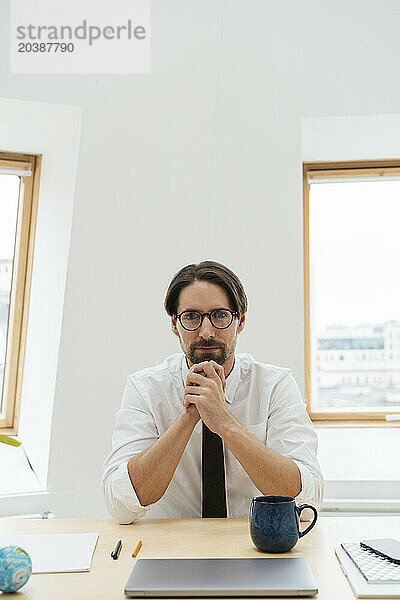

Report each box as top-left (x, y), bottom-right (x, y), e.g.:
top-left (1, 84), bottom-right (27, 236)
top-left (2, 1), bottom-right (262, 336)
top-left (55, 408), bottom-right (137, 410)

top-left (0, 152), bottom-right (40, 433)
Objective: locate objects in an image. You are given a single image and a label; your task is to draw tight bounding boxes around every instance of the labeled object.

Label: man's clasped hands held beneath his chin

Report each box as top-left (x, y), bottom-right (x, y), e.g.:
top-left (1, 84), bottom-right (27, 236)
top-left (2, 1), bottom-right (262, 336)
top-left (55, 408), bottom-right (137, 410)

top-left (183, 360), bottom-right (231, 435)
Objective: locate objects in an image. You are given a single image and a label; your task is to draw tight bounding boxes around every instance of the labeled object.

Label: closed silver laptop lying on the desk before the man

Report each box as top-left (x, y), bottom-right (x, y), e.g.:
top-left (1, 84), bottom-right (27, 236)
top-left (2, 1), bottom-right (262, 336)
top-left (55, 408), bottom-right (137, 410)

top-left (125, 558), bottom-right (318, 598)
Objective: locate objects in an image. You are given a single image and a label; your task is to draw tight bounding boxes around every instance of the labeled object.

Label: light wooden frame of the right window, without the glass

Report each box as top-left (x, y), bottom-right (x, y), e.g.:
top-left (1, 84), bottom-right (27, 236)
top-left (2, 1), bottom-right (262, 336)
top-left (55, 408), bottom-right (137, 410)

top-left (303, 159), bottom-right (400, 427)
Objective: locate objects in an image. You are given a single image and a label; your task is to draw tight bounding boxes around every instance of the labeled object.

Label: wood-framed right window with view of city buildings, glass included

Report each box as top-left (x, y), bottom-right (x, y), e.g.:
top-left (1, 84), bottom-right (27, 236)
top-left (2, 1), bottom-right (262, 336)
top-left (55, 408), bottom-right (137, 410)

top-left (304, 161), bottom-right (400, 421)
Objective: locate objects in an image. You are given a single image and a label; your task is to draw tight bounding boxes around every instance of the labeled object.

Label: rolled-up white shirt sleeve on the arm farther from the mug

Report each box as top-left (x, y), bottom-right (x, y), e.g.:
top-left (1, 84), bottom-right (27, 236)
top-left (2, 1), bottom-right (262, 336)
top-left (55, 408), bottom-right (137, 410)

top-left (102, 376), bottom-right (159, 524)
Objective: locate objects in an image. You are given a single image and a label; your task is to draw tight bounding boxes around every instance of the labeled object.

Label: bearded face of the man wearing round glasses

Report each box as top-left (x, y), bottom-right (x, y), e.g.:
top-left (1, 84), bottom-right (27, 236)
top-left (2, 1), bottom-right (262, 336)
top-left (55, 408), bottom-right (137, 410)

top-left (171, 281), bottom-right (245, 372)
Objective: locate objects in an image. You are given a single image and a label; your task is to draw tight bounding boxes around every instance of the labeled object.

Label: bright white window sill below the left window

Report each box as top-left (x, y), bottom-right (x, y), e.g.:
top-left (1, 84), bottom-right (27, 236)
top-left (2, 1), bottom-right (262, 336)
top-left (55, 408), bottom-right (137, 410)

top-left (0, 444), bottom-right (44, 495)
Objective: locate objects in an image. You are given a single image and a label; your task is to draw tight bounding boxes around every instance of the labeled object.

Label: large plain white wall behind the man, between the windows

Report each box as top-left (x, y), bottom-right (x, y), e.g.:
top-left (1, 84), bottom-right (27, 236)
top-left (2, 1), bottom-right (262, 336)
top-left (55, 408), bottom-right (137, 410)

top-left (0, 0), bottom-right (400, 516)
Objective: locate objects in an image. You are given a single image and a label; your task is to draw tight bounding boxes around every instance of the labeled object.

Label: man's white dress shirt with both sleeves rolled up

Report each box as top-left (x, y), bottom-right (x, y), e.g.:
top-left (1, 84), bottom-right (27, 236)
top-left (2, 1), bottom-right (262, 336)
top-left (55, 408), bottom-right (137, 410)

top-left (102, 353), bottom-right (323, 523)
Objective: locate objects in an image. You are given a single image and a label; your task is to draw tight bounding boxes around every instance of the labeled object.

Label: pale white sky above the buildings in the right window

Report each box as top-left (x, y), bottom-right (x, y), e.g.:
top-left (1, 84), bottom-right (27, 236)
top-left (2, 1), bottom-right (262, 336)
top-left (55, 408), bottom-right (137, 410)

top-left (310, 181), bottom-right (400, 331)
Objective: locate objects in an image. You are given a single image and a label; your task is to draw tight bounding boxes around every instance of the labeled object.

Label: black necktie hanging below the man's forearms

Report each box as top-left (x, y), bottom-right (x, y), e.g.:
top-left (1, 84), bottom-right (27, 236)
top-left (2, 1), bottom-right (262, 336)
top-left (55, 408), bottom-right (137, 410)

top-left (201, 422), bottom-right (226, 518)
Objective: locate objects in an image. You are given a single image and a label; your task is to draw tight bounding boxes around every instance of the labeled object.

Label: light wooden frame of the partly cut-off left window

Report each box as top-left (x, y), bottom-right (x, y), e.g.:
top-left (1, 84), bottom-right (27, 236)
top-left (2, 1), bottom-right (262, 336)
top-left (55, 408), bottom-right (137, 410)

top-left (0, 151), bottom-right (42, 435)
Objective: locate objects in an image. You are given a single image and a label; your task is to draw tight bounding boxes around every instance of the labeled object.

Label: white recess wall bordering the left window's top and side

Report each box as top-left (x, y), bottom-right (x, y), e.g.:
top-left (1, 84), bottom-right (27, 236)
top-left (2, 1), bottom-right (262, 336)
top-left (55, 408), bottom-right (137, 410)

top-left (0, 98), bottom-right (81, 486)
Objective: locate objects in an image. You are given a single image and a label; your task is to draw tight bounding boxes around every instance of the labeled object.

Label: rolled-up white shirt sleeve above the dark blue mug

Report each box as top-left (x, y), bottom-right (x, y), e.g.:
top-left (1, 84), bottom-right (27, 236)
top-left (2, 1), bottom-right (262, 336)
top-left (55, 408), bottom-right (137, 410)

top-left (267, 371), bottom-right (324, 520)
